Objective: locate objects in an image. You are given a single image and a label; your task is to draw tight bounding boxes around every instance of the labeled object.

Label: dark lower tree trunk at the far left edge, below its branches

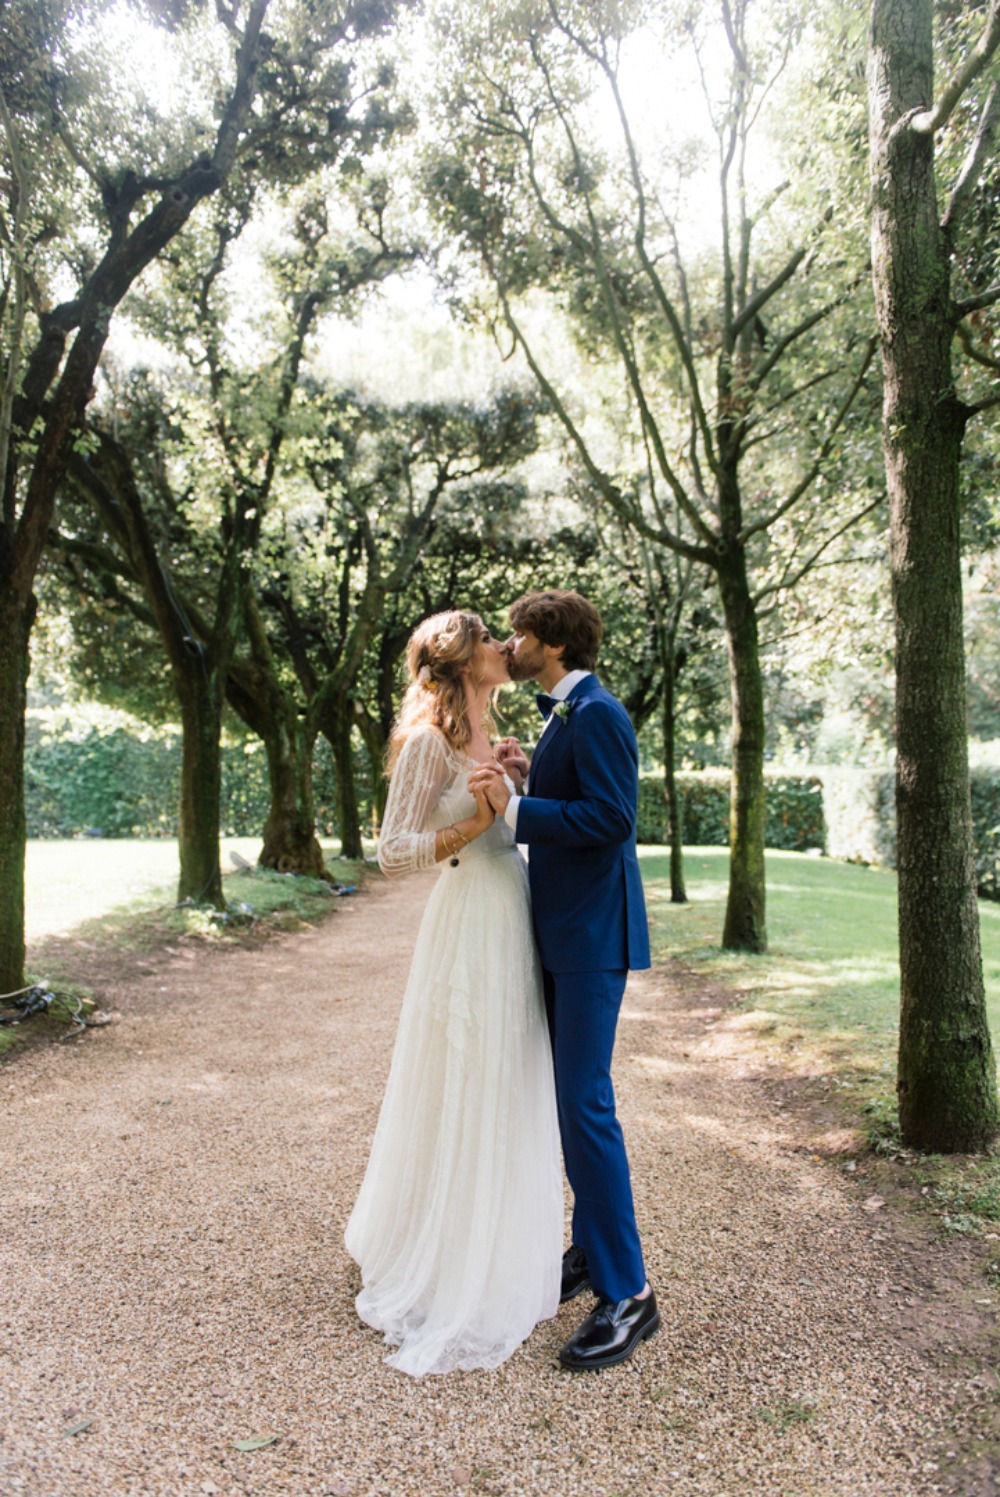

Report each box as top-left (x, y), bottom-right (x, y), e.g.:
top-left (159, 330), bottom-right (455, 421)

top-left (0, 596), bottom-right (36, 993)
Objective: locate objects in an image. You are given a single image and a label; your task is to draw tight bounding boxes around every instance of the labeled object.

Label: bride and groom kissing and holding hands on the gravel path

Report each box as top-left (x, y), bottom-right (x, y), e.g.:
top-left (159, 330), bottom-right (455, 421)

top-left (346, 591), bottom-right (660, 1377)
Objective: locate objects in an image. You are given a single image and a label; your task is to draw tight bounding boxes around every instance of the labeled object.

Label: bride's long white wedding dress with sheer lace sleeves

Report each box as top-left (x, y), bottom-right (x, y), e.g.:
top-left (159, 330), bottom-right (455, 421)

top-left (346, 728), bottom-right (563, 1377)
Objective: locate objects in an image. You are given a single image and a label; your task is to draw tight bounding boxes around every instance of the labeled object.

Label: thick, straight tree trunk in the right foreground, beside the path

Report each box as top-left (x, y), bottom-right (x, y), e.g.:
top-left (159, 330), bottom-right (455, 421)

top-left (868, 0), bottom-right (997, 1153)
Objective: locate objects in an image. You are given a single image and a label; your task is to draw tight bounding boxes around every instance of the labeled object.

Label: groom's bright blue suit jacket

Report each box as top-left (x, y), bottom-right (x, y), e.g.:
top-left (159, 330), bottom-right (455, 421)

top-left (516, 675), bottom-right (650, 972)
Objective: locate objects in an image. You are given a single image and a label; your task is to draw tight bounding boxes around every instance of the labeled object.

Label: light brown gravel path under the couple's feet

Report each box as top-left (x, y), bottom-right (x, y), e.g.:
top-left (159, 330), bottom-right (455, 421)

top-left (0, 876), bottom-right (996, 1497)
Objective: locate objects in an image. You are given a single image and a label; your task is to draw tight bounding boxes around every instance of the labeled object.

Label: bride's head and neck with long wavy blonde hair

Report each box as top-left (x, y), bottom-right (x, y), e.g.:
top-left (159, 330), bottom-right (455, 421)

top-left (385, 609), bottom-right (493, 774)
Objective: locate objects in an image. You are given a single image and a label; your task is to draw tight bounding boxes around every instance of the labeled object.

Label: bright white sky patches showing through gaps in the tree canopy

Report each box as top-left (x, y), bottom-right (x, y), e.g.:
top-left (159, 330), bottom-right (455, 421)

top-left (95, 4), bottom-right (780, 401)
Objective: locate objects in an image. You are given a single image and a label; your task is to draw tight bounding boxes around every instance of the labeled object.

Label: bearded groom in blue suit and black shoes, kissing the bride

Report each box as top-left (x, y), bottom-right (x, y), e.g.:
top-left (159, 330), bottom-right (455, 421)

top-left (470, 590), bottom-right (660, 1371)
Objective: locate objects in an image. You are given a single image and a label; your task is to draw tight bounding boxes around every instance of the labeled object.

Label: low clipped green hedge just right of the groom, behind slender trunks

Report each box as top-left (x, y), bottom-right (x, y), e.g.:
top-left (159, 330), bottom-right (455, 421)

top-left (636, 769), bottom-right (825, 852)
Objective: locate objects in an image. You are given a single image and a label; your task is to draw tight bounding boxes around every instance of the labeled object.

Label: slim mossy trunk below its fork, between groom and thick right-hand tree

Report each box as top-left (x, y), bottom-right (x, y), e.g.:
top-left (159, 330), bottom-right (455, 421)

top-left (719, 545), bottom-right (768, 952)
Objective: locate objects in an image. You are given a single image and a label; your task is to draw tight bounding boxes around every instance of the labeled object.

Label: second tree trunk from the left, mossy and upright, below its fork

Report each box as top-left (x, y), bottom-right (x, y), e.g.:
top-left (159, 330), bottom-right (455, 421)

top-left (174, 660), bottom-right (226, 910)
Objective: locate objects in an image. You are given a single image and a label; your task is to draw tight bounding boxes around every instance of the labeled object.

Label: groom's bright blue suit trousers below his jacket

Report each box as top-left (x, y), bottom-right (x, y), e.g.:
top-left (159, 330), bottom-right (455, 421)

top-left (543, 972), bottom-right (645, 1302)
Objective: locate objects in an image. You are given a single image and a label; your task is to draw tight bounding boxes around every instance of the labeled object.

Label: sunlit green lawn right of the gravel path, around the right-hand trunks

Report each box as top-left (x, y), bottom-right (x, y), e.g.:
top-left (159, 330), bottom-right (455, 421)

top-left (639, 847), bottom-right (1000, 1233)
